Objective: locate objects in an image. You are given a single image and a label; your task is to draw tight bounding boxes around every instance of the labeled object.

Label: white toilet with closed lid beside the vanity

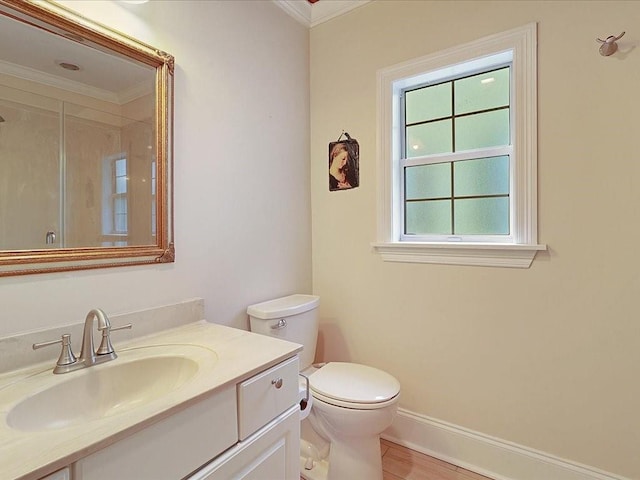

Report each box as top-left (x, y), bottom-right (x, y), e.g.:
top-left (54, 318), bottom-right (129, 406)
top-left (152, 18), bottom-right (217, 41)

top-left (247, 295), bottom-right (400, 480)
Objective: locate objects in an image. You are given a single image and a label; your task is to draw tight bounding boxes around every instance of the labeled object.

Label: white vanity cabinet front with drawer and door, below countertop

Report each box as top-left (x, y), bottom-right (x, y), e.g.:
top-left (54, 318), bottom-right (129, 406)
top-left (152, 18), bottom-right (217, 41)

top-left (71, 356), bottom-right (300, 480)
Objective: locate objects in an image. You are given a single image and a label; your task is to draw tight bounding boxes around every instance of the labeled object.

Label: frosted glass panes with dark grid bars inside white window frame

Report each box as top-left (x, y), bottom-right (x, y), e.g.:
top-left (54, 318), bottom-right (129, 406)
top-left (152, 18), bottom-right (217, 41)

top-left (399, 64), bottom-right (512, 241)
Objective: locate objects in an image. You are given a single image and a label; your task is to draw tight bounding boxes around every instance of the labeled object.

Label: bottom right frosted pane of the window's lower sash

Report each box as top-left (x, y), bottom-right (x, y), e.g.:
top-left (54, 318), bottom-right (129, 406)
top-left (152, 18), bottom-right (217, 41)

top-left (454, 197), bottom-right (509, 235)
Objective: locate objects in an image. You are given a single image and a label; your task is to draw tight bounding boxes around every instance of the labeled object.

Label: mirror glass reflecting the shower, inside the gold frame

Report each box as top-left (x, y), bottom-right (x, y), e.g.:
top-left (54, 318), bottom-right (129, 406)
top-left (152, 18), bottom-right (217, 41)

top-left (0, 9), bottom-right (156, 250)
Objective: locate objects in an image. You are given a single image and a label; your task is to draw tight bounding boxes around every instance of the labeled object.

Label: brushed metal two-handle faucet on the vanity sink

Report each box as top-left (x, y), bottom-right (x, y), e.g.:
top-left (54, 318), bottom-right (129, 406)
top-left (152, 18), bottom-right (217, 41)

top-left (33, 308), bottom-right (131, 373)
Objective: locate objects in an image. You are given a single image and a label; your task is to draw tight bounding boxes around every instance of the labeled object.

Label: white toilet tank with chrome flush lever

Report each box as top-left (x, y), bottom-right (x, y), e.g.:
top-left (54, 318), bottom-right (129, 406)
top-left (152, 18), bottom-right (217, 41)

top-left (247, 294), bottom-right (320, 371)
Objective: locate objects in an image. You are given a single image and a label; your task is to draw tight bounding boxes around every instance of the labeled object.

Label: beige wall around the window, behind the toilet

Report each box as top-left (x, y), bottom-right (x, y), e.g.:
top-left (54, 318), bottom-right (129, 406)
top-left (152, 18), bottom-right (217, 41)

top-left (311, 0), bottom-right (640, 478)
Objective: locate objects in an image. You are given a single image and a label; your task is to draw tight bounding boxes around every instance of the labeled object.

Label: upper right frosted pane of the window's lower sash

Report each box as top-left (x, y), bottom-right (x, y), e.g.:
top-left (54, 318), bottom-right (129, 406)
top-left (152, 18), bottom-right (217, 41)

top-left (453, 156), bottom-right (509, 197)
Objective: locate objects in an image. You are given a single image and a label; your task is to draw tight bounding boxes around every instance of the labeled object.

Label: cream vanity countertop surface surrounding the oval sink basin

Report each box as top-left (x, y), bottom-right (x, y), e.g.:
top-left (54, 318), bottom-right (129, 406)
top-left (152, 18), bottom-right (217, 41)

top-left (0, 320), bottom-right (302, 480)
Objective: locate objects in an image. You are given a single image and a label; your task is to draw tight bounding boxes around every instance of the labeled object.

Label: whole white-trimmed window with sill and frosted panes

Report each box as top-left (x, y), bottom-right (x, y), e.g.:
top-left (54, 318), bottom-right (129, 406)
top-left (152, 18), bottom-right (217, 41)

top-left (374, 24), bottom-right (546, 267)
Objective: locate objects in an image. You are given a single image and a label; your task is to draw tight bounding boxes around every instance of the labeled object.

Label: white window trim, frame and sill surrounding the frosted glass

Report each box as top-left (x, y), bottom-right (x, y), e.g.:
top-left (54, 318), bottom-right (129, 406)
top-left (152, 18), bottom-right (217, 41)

top-left (373, 23), bottom-right (546, 268)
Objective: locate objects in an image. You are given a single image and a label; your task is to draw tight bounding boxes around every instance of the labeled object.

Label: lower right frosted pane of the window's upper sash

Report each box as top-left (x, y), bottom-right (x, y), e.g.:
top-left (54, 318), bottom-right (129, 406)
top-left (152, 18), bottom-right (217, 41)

top-left (456, 108), bottom-right (509, 152)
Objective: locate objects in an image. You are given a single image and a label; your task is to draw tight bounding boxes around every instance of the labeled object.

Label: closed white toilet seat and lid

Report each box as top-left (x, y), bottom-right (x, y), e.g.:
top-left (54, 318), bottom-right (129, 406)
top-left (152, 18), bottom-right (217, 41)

top-left (309, 362), bottom-right (400, 410)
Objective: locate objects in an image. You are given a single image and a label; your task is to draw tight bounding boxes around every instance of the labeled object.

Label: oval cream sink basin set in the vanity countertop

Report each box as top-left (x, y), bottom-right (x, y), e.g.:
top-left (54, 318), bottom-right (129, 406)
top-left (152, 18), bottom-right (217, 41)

top-left (1, 345), bottom-right (217, 431)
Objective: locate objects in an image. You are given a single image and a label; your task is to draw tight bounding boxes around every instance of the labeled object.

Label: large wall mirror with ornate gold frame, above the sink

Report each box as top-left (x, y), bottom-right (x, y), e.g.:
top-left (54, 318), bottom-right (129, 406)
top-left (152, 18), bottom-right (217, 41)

top-left (0, 0), bottom-right (175, 276)
